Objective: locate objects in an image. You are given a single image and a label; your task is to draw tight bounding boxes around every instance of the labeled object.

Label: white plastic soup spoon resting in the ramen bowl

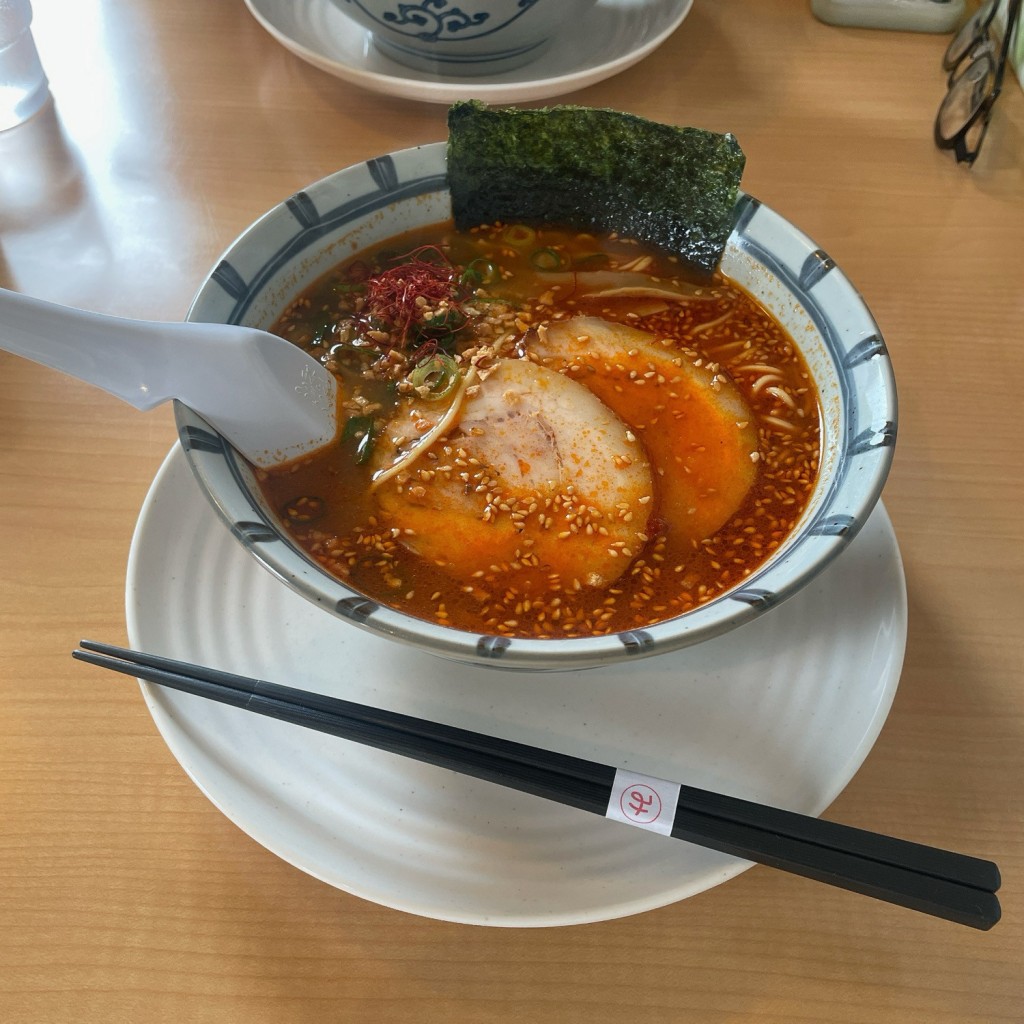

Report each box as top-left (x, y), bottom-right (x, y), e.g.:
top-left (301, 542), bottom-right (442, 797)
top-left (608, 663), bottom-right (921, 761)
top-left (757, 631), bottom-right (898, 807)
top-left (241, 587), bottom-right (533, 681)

top-left (0, 289), bottom-right (338, 466)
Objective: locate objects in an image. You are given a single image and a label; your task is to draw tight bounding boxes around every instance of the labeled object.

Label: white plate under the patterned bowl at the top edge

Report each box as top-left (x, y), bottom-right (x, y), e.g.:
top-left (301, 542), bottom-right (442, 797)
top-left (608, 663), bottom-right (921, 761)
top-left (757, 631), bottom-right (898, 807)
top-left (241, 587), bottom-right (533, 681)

top-left (246, 0), bottom-right (693, 103)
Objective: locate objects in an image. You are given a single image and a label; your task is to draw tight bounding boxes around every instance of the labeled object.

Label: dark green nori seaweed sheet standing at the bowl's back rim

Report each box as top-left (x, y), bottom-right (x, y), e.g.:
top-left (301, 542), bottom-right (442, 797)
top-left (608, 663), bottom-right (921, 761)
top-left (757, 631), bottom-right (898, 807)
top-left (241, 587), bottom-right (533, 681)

top-left (447, 100), bottom-right (744, 273)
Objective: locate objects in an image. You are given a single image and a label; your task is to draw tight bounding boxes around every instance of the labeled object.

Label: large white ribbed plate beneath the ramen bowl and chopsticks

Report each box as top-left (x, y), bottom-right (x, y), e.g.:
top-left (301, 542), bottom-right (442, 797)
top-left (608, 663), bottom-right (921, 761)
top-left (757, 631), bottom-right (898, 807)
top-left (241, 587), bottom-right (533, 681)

top-left (127, 447), bottom-right (906, 927)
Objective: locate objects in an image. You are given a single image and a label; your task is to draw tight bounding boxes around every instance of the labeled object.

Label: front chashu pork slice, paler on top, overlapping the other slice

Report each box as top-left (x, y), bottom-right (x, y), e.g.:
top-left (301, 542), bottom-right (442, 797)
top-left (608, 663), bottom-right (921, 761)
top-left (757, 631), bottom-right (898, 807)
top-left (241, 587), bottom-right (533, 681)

top-left (375, 359), bottom-right (652, 596)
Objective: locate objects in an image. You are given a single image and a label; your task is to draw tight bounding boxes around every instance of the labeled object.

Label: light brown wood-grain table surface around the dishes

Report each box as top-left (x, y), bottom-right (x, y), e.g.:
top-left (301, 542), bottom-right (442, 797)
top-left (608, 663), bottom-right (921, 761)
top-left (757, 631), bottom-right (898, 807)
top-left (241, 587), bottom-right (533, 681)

top-left (0, 0), bottom-right (1024, 1024)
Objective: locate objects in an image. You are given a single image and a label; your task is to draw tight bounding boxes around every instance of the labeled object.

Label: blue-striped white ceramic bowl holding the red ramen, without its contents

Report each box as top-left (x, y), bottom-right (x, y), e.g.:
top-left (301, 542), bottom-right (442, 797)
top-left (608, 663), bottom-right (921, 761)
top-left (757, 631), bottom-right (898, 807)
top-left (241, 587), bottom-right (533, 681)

top-left (175, 142), bottom-right (896, 671)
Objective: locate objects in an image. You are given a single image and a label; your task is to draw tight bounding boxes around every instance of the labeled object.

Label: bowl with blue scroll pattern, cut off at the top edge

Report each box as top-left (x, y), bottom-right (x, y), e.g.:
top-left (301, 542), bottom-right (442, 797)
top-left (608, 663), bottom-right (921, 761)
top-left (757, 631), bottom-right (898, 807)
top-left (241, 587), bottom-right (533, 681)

top-left (332, 0), bottom-right (597, 77)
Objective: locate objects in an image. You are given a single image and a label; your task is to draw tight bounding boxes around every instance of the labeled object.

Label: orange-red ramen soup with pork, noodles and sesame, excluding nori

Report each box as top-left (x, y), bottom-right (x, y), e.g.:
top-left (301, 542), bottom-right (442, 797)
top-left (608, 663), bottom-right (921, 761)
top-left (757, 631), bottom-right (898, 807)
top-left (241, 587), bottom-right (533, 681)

top-left (259, 224), bottom-right (820, 638)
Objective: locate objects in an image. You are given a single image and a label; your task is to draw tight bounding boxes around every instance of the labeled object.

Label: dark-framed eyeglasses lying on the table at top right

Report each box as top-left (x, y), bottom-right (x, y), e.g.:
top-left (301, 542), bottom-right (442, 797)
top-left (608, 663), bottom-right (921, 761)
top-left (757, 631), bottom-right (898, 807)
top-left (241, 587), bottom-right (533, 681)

top-left (935, 0), bottom-right (1022, 164)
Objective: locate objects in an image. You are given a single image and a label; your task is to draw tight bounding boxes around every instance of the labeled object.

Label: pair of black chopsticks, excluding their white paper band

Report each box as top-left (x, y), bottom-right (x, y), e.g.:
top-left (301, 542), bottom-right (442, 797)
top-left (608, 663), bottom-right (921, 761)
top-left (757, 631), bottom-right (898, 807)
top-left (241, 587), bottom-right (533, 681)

top-left (74, 640), bottom-right (999, 929)
